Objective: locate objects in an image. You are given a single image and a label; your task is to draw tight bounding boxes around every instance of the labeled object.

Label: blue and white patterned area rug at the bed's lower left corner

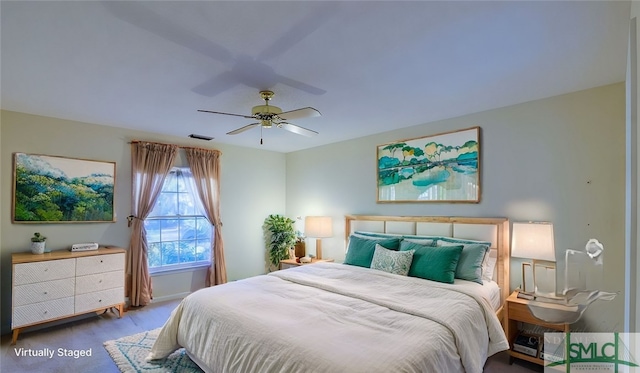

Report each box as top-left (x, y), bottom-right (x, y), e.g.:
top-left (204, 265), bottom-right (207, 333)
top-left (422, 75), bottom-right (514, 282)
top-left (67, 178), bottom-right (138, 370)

top-left (104, 328), bottom-right (202, 373)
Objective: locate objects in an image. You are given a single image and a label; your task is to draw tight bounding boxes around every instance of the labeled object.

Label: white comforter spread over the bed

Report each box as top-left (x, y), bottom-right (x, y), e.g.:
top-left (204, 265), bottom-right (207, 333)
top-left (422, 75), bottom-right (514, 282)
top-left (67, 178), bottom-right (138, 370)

top-left (148, 263), bottom-right (508, 373)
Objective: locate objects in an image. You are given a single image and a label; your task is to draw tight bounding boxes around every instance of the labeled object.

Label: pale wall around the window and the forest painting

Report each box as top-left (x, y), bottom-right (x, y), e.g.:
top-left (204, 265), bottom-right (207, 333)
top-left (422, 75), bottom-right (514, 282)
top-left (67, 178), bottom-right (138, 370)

top-left (0, 111), bottom-right (285, 333)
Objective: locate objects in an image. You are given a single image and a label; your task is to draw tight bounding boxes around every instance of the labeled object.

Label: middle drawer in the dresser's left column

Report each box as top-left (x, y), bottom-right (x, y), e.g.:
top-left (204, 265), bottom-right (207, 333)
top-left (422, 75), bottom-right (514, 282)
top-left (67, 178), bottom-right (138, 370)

top-left (13, 278), bottom-right (75, 307)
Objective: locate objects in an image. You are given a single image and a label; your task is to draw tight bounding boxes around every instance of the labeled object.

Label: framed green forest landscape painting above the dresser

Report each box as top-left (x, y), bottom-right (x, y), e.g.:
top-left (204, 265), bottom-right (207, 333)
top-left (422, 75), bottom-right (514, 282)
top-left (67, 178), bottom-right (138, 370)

top-left (12, 153), bottom-right (116, 223)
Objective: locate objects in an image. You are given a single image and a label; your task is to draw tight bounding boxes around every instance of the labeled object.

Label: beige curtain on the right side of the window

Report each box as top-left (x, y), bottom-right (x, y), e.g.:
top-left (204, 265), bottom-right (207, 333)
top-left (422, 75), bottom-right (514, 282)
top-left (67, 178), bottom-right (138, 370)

top-left (184, 148), bottom-right (227, 286)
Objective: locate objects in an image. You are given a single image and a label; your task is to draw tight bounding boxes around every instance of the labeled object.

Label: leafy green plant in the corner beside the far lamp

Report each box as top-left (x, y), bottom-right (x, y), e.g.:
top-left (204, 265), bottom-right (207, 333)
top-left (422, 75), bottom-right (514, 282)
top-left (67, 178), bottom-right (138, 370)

top-left (263, 214), bottom-right (297, 268)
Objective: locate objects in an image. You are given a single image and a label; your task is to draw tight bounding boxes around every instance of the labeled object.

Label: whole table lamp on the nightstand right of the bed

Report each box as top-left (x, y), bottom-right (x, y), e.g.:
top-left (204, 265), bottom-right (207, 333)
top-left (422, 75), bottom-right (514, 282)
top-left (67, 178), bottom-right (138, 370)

top-left (511, 222), bottom-right (556, 298)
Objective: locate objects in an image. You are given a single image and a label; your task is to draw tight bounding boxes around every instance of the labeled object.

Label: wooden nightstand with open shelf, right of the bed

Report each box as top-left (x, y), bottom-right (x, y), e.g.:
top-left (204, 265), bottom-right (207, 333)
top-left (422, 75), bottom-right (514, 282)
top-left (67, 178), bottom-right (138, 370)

top-left (505, 291), bottom-right (569, 365)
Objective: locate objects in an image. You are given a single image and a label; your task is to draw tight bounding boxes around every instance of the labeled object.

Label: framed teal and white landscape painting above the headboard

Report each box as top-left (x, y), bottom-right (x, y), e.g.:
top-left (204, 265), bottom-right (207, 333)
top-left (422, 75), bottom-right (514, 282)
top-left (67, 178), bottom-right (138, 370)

top-left (376, 127), bottom-right (480, 203)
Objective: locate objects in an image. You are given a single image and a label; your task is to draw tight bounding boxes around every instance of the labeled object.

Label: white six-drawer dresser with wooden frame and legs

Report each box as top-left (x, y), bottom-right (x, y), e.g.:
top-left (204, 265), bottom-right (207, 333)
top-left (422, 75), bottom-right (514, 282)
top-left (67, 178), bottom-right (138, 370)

top-left (11, 248), bottom-right (125, 344)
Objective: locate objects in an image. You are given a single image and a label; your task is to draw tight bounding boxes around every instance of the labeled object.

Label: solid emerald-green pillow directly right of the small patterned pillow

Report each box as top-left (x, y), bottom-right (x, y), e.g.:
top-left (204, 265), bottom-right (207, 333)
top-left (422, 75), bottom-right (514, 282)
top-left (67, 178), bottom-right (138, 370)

top-left (400, 241), bottom-right (462, 284)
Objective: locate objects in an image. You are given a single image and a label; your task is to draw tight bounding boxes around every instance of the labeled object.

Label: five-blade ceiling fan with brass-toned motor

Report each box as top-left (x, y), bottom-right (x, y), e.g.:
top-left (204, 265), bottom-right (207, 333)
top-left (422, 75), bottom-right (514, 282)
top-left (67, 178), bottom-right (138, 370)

top-left (198, 91), bottom-right (321, 144)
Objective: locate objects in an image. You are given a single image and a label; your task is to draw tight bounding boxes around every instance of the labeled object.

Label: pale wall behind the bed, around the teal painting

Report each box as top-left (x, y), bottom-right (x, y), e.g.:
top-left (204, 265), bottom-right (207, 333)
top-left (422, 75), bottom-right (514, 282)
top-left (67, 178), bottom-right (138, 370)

top-left (286, 83), bottom-right (625, 331)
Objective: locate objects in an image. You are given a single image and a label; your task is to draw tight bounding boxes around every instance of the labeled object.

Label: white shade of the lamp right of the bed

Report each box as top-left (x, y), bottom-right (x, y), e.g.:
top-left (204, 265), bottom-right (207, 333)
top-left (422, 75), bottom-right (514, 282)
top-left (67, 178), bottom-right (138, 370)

top-left (511, 223), bottom-right (556, 262)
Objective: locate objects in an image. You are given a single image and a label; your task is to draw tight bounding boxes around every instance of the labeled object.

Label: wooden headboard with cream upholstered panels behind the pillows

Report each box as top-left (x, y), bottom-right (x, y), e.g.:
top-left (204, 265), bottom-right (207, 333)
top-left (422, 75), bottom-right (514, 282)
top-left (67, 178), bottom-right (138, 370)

top-left (344, 215), bottom-right (509, 310)
